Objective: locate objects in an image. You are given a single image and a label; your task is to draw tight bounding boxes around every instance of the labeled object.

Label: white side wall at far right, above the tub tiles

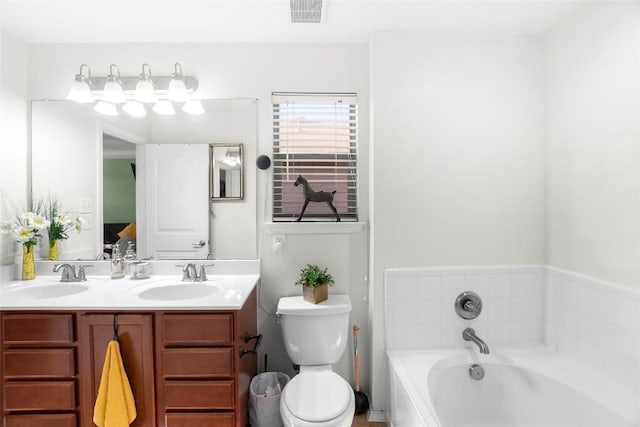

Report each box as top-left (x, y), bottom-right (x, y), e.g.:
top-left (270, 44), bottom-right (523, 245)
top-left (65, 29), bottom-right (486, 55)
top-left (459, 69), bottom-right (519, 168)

top-left (545, 2), bottom-right (640, 287)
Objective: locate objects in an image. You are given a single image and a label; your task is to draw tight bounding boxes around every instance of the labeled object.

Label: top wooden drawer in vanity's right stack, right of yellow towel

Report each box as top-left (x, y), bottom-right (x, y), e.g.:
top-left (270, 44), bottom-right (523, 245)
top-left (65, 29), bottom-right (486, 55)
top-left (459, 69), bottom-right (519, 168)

top-left (161, 313), bottom-right (233, 346)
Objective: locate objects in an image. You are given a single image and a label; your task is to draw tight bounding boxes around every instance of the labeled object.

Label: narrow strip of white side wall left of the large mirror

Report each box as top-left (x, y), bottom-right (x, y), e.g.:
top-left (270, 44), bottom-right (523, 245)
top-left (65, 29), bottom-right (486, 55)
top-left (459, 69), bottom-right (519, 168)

top-left (0, 32), bottom-right (29, 278)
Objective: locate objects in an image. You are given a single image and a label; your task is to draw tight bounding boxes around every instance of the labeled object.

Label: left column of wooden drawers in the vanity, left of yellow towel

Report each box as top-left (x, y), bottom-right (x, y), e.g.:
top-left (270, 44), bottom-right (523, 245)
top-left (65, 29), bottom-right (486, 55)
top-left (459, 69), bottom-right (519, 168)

top-left (0, 312), bottom-right (79, 427)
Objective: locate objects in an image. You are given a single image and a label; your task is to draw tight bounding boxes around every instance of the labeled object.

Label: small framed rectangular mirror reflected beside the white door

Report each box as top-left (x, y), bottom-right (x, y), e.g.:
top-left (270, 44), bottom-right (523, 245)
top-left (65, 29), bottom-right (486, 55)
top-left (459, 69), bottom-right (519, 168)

top-left (209, 143), bottom-right (244, 202)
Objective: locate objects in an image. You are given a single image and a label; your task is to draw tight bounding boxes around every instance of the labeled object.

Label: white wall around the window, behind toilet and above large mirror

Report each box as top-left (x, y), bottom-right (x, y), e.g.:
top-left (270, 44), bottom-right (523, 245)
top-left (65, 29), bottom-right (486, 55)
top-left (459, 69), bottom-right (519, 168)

top-left (29, 40), bottom-right (369, 390)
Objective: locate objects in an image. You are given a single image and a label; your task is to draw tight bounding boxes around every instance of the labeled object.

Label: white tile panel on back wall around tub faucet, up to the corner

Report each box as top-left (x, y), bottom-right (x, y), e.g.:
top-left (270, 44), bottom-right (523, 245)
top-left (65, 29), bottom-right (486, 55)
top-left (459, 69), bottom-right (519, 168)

top-left (385, 265), bottom-right (544, 350)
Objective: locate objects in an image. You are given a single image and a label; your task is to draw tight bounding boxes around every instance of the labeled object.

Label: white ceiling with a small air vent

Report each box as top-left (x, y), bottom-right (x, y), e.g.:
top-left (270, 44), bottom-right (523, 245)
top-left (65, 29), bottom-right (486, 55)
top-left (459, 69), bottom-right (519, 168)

top-left (0, 0), bottom-right (585, 44)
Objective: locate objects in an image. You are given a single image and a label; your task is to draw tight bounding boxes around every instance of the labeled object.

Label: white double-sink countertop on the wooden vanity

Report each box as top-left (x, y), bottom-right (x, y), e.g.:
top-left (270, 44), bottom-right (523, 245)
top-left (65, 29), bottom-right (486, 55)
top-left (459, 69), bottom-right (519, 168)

top-left (0, 260), bottom-right (260, 311)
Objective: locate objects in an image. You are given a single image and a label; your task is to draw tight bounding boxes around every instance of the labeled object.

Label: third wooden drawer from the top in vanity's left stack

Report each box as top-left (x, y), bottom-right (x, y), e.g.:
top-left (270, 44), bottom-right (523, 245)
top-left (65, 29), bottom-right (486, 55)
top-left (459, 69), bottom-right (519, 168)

top-left (3, 381), bottom-right (76, 411)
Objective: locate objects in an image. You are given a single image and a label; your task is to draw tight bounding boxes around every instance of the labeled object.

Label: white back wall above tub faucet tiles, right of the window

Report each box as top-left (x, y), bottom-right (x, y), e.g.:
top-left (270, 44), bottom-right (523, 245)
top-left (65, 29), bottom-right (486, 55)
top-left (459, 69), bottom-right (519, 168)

top-left (370, 33), bottom-right (544, 409)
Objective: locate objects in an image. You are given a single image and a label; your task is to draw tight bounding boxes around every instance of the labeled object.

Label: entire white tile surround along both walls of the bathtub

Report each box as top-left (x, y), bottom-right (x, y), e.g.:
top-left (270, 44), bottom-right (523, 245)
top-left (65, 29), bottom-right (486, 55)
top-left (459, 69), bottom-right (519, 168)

top-left (385, 265), bottom-right (640, 402)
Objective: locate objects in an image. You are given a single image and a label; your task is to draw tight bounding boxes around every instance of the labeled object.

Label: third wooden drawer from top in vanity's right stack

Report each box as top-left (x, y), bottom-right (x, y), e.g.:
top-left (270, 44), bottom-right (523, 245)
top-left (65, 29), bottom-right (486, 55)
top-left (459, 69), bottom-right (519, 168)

top-left (164, 380), bottom-right (233, 409)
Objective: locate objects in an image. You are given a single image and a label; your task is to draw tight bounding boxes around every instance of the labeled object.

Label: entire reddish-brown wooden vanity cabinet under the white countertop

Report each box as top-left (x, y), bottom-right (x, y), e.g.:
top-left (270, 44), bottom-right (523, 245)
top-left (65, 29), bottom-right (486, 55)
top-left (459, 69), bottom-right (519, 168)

top-left (0, 291), bottom-right (257, 427)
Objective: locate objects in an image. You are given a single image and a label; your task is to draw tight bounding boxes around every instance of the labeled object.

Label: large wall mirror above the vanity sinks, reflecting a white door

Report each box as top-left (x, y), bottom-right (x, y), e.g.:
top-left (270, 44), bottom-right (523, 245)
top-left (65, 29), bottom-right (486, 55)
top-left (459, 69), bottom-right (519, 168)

top-left (30, 99), bottom-right (258, 260)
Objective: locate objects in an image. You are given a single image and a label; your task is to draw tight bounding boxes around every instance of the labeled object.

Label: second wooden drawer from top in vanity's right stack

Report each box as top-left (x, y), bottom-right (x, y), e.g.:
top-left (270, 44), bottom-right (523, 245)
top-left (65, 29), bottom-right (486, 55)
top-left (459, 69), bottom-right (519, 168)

top-left (162, 347), bottom-right (233, 378)
